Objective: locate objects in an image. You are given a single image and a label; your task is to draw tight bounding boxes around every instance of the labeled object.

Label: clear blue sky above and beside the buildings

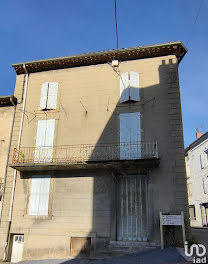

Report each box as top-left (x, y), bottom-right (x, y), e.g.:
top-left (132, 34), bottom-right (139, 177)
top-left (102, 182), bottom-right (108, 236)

top-left (0, 0), bottom-right (208, 146)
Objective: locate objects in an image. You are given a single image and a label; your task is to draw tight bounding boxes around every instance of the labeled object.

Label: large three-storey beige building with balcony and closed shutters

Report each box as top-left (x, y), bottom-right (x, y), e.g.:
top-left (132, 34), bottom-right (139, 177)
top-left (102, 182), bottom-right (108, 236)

top-left (0, 42), bottom-right (189, 261)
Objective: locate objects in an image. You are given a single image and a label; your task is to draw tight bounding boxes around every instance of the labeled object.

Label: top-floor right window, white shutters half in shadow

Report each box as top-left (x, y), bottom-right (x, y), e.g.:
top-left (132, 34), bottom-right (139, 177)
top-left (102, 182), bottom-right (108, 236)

top-left (120, 71), bottom-right (140, 103)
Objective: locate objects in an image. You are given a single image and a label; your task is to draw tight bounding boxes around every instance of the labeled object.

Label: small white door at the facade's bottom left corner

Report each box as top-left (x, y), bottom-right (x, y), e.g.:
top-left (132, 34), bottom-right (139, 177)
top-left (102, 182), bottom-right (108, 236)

top-left (11, 234), bottom-right (24, 263)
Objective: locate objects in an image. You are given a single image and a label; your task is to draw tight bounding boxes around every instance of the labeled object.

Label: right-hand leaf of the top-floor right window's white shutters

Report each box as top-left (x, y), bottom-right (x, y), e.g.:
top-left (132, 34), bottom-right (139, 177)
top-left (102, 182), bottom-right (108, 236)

top-left (129, 71), bottom-right (140, 101)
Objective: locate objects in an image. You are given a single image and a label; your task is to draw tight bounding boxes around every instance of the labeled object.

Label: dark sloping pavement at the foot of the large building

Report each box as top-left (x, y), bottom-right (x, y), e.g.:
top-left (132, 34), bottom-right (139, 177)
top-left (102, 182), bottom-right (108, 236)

top-left (15, 248), bottom-right (188, 264)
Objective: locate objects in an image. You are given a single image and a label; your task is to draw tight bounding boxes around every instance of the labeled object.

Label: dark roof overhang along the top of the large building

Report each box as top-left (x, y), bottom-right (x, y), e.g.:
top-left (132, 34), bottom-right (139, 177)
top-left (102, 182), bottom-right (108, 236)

top-left (12, 42), bottom-right (187, 74)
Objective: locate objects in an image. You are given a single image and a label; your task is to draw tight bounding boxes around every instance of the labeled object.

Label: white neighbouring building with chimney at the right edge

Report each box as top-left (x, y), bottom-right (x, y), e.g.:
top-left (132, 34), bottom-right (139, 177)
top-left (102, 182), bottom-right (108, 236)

top-left (185, 132), bottom-right (208, 227)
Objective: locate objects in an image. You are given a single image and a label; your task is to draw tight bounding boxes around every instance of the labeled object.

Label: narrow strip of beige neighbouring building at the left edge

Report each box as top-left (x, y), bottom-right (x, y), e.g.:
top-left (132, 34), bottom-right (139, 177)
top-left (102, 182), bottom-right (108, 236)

top-left (0, 95), bottom-right (17, 212)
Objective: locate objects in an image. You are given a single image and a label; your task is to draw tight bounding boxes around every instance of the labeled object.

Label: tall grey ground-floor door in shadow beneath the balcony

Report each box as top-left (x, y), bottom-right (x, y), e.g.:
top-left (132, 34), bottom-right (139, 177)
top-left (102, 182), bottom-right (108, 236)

top-left (117, 175), bottom-right (148, 241)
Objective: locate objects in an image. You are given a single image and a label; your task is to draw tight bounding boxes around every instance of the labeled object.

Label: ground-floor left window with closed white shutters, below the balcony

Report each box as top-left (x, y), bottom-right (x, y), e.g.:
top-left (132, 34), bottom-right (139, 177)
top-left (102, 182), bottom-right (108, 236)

top-left (28, 176), bottom-right (50, 216)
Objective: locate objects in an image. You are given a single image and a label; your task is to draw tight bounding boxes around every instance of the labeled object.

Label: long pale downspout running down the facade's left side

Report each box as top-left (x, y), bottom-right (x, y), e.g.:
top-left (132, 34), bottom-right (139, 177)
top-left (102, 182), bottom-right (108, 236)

top-left (3, 64), bottom-right (29, 261)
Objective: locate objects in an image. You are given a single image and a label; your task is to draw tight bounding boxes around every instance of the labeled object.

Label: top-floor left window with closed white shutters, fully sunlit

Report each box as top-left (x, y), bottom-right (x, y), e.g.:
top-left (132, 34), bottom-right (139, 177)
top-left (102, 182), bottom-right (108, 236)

top-left (40, 82), bottom-right (58, 110)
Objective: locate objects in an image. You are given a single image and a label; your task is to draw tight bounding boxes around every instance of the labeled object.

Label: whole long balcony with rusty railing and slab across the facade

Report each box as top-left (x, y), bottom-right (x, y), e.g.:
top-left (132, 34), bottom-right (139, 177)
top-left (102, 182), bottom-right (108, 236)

top-left (10, 142), bottom-right (159, 171)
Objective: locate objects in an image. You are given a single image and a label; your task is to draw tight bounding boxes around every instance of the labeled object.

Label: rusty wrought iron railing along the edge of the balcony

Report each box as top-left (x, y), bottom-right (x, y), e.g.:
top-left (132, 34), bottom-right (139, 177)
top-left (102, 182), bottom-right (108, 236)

top-left (12, 142), bottom-right (158, 164)
